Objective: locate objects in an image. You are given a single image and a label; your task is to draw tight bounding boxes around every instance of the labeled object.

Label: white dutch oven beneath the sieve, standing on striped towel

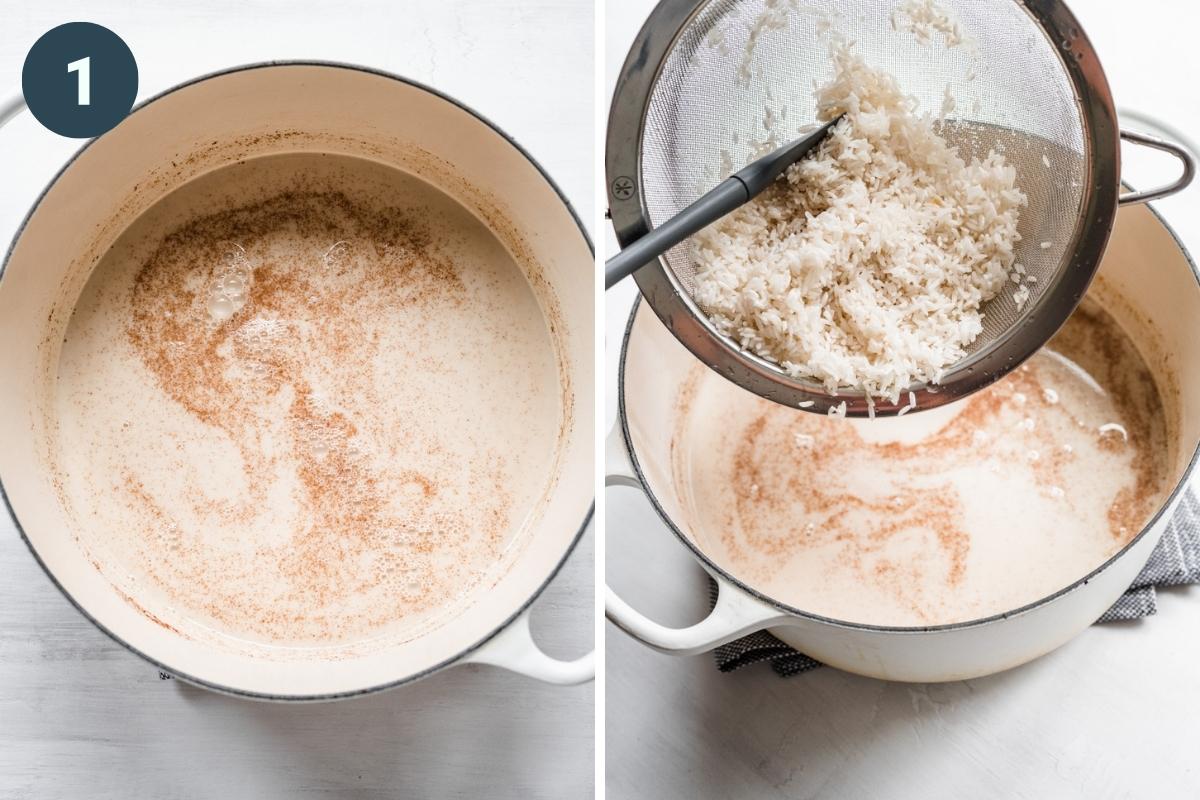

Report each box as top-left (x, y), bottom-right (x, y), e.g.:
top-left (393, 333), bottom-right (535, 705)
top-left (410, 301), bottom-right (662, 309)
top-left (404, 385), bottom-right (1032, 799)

top-left (606, 200), bottom-right (1200, 681)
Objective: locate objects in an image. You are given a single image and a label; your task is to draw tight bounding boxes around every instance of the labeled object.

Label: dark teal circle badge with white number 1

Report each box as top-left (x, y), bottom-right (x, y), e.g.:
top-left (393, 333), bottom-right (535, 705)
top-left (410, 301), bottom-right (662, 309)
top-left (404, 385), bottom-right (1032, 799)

top-left (20, 23), bottom-right (138, 139)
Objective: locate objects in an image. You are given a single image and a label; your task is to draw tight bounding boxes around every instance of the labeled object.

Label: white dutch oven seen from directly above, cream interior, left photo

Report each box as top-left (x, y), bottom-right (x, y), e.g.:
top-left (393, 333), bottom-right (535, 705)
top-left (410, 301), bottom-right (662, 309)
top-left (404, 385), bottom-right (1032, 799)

top-left (0, 62), bottom-right (594, 699)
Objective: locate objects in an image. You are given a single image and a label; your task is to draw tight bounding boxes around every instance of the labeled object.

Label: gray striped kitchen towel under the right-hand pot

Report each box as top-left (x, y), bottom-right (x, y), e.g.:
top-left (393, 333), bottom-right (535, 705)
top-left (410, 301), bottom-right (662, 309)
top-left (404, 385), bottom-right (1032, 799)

top-left (710, 487), bottom-right (1200, 678)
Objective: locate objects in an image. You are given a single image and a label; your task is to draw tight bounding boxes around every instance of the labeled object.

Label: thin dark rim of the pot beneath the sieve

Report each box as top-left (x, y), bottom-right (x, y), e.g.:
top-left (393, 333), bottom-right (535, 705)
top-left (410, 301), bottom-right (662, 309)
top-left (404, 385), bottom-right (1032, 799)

top-left (617, 203), bottom-right (1200, 634)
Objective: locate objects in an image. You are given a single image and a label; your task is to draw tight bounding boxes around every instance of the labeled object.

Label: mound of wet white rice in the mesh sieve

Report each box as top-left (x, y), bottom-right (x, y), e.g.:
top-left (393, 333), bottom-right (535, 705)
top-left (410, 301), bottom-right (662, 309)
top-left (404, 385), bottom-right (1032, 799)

top-left (694, 43), bottom-right (1026, 403)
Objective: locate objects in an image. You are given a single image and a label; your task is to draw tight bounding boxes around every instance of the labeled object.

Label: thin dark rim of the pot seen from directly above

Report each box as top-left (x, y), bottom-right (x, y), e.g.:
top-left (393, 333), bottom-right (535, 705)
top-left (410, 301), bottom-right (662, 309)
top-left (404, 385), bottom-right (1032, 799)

top-left (0, 59), bottom-right (595, 703)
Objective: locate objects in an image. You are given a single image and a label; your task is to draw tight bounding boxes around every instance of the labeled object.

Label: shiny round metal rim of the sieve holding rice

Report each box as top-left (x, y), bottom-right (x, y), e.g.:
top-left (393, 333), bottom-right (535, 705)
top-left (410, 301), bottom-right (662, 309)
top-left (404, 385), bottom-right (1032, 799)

top-left (605, 0), bottom-right (1121, 417)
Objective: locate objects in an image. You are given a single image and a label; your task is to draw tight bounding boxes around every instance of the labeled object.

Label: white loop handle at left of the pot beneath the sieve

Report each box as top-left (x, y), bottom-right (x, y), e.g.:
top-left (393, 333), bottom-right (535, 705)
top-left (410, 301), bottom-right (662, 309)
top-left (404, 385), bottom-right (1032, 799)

top-left (604, 422), bottom-right (787, 656)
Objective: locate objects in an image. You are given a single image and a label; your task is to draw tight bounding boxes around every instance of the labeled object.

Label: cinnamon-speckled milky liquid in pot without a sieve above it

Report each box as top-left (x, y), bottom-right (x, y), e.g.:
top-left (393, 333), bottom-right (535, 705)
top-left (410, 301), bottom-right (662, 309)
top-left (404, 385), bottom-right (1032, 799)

top-left (55, 154), bottom-right (563, 649)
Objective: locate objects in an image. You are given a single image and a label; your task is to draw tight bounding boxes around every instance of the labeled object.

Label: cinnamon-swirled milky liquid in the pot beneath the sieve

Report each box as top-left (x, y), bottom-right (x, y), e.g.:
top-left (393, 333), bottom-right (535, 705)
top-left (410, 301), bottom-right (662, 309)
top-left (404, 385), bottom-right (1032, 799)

top-left (672, 301), bottom-right (1170, 626)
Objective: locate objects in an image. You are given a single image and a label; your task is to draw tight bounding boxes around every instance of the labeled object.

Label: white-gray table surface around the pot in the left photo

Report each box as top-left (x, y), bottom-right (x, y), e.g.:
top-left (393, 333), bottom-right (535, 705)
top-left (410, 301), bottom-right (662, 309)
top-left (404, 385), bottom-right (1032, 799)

top-left (0, 0), bottom-right (595, 800)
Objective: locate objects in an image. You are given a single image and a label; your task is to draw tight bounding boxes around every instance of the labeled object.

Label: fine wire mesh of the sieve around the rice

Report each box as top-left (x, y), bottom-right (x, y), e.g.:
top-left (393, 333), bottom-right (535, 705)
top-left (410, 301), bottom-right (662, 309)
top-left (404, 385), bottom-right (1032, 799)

top-left (641, 0), bottom-right (1087, 351)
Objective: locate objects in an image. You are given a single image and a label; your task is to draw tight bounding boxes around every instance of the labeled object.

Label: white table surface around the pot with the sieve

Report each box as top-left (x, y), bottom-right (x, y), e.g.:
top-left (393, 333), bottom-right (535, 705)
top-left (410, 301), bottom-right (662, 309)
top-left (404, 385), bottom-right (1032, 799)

top-left (605, 0), bottom-right (1200, 800)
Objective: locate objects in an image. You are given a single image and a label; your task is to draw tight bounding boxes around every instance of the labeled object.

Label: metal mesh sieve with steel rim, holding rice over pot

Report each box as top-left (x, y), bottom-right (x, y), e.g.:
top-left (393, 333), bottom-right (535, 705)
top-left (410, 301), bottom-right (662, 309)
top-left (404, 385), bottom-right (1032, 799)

top-left (606, 0), bottom-right (1187, 415)
